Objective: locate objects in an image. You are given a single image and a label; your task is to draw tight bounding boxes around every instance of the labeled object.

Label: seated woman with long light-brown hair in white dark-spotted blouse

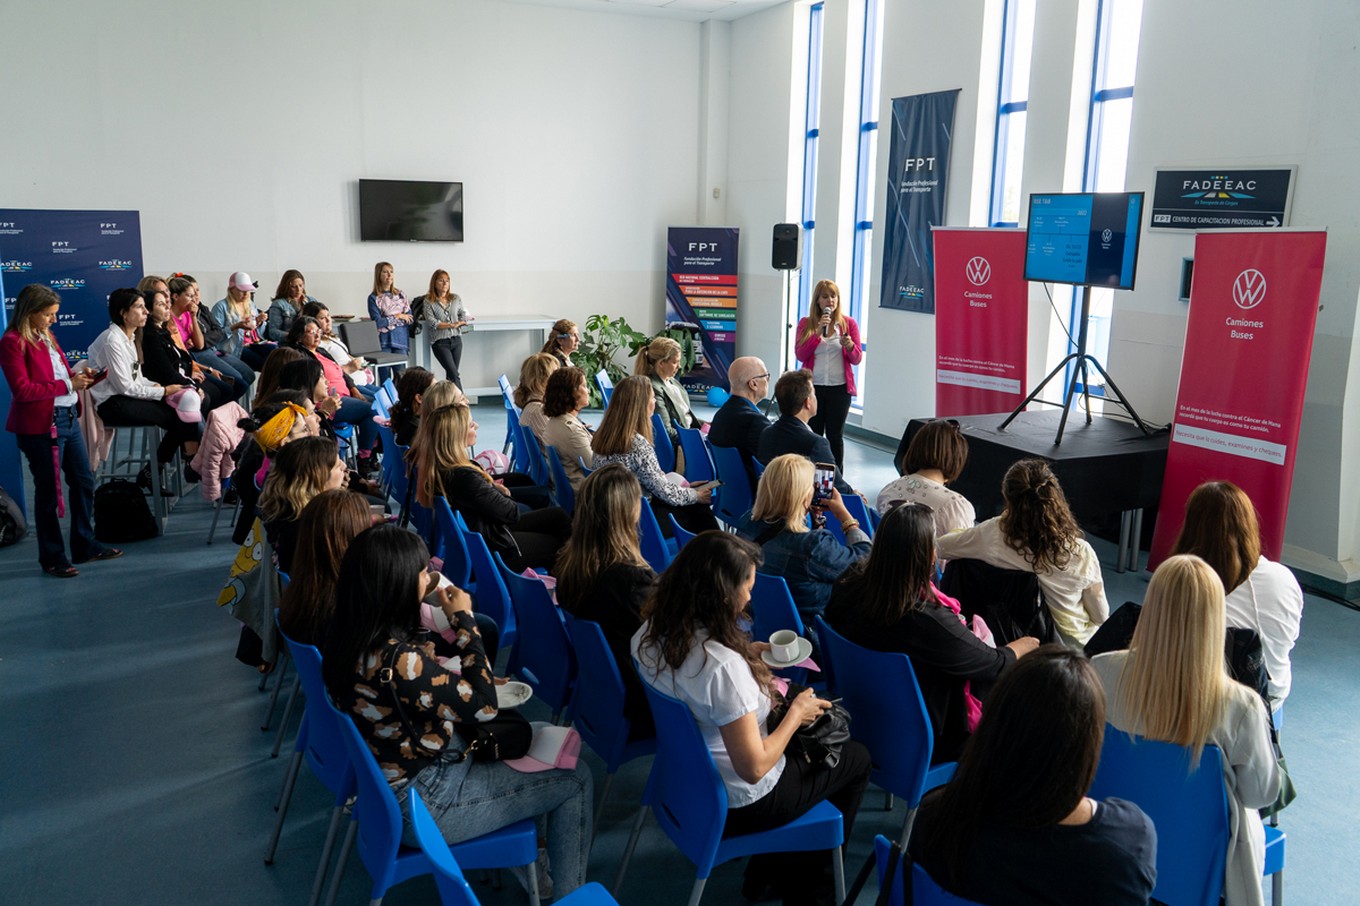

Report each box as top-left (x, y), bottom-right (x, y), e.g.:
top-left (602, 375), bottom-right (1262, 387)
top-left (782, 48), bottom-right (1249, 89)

top-left (590, 374), bottom-right (718, 533)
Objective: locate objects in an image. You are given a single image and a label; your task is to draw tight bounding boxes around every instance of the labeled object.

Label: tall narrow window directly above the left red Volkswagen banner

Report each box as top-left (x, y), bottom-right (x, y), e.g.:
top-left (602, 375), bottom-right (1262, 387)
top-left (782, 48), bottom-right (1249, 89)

top-left (987, 0), bottom-right (1035, 227)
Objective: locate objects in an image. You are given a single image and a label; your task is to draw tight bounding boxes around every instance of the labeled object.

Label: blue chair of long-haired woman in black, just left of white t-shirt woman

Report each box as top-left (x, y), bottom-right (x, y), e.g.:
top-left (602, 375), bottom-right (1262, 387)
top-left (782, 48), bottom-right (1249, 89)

top-left (567, 615), bottom-right (657, 833)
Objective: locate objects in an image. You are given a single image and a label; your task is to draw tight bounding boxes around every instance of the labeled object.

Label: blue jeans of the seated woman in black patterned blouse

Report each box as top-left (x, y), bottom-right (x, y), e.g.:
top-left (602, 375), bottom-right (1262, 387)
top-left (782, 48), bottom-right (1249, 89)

top-left (401, 756), bottom-right (594, 896)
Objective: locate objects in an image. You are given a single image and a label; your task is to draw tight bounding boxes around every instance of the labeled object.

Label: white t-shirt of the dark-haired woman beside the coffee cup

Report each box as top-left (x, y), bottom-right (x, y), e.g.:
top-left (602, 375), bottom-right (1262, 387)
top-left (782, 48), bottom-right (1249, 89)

top-left (631, 623), bottom-right (785, 808)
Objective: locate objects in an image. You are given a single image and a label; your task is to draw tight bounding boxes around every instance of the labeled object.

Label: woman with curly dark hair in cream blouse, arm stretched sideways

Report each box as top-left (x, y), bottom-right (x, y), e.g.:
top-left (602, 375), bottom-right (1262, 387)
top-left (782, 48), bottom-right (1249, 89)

top-left (936, 460), bottom-right (1110, 648)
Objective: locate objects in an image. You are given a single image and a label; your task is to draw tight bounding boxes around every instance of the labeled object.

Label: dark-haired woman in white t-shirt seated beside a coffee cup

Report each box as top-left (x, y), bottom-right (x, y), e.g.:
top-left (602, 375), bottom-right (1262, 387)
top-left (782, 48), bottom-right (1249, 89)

top-left (628, 530), bottom-right (869, 905)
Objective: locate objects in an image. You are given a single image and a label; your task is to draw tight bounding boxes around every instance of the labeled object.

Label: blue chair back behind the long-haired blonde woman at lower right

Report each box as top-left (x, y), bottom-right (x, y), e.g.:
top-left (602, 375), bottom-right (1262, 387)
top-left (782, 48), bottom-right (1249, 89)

top-left (1089, 724), bottom-right (1229, 905)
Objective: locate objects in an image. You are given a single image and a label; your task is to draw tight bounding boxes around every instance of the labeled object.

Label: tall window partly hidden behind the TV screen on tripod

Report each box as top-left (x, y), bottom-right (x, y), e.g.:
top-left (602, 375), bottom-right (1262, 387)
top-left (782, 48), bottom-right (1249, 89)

top-left (1069, 0), bottom-right (1142, 396)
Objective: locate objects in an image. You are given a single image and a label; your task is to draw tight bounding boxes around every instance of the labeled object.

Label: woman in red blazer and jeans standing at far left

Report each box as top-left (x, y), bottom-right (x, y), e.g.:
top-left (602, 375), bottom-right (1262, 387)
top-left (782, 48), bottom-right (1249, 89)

top-left (0, 283), bottom-right (122, 578)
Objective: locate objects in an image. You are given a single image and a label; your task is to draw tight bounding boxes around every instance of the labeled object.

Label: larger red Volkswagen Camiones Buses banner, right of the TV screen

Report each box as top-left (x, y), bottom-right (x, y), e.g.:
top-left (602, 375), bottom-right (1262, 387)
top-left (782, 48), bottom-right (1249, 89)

top-left (1148, 230), bottom-right (1327, 569)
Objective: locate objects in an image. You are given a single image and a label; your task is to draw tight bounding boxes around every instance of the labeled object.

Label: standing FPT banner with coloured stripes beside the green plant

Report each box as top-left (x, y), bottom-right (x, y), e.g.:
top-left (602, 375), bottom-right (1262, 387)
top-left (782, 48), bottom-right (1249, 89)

top-left (666, 227), bottom-right (738, 393)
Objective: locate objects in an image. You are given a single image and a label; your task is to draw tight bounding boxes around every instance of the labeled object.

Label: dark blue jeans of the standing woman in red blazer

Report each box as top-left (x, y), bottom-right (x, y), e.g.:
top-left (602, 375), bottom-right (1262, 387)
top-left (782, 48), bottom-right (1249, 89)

top-left (16, 407), bottom-right (103, 569)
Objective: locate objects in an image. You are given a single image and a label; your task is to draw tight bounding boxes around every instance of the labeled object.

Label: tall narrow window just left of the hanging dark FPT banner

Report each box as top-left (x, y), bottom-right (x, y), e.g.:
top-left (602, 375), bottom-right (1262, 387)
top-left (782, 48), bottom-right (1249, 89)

top-left (847, 0), bottom-right (883, 411)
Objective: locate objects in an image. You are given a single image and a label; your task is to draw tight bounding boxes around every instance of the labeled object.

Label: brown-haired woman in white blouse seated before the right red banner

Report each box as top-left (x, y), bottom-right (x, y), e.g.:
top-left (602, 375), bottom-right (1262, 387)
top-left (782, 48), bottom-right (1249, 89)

top-left (1171, 482), bottom-right (1303, 709)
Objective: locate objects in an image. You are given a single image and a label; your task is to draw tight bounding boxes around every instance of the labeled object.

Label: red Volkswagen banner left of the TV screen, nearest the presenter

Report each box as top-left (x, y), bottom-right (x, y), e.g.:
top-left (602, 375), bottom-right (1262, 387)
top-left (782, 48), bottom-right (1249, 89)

top-left (933, 227), bottom-right (1030, 415)
